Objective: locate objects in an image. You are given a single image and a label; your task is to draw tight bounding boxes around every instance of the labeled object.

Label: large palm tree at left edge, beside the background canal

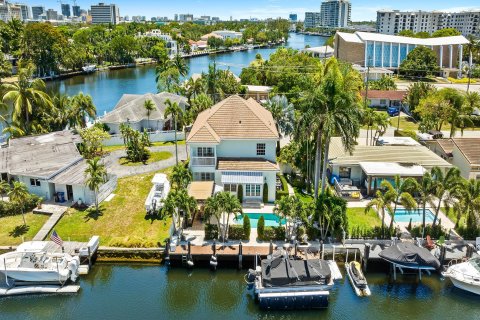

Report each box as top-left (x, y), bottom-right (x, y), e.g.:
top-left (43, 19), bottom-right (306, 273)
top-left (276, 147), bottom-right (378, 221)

top-left (1, 69), bottom-right (53, 133)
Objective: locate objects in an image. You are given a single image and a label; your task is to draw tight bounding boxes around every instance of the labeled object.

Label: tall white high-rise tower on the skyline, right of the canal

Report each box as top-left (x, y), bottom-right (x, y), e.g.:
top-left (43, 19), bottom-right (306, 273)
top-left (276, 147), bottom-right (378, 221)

top-left (320, 0), bottom-right (352, 28)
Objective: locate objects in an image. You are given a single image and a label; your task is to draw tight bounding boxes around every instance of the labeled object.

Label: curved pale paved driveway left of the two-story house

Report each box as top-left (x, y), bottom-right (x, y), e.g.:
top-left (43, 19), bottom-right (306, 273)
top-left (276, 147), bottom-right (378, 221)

top-left (105, 145), bottom-right (187, 178)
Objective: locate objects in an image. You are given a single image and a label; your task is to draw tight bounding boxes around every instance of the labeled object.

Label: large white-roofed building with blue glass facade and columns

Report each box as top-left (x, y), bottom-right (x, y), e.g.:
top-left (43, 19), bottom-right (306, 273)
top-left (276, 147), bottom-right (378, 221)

top-left (334, 31), bottom-right (469, 76)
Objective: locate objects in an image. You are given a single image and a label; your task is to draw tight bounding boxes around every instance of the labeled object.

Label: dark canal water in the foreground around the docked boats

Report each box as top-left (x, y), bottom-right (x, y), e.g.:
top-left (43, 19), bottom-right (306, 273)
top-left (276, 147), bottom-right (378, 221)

top-left (0, 264), bottom-right (480, 320)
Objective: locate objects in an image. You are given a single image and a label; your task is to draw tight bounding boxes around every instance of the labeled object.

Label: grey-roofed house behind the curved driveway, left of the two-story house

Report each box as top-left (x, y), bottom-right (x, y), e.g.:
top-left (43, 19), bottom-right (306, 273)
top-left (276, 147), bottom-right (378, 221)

top-left (100, 92), bottom-right (188, 135)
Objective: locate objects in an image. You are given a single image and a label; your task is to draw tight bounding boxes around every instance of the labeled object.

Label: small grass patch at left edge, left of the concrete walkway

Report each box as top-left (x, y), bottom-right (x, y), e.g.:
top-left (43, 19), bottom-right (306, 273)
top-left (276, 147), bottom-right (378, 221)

top-left (0, 212), bottom-right (49, 246)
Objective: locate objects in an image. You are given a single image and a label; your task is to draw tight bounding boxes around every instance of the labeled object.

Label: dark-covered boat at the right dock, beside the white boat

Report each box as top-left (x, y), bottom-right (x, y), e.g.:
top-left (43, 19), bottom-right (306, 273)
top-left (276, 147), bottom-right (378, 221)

top-left (378, 242), bottom-right (440, 269)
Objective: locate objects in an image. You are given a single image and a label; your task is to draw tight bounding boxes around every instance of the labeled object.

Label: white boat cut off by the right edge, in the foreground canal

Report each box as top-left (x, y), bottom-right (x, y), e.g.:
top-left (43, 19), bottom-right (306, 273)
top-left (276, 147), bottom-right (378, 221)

top-left (442, 258), bottom-right (480, 295)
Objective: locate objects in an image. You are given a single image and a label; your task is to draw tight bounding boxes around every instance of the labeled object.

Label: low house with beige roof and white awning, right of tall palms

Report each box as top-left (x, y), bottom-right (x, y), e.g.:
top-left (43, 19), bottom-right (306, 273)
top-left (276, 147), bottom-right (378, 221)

top-left (328, 137), bottom-right (452, 195)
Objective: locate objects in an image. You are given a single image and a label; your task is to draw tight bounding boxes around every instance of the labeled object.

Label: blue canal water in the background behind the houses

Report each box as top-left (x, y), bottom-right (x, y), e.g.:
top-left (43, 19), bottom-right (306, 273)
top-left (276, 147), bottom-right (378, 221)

top-left (48, 33), bottom-right (325, 115)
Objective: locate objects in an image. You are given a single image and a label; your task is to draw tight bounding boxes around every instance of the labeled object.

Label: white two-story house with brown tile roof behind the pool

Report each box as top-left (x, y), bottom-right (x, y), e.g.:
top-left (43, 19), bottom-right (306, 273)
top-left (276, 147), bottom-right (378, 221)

top-left (187, 96), bottom-right (280, 202)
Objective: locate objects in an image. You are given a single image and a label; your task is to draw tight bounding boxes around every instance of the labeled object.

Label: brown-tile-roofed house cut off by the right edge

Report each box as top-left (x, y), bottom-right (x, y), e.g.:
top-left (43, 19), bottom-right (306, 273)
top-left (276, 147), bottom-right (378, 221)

top-left (425, 138), bottom-right (480, 179)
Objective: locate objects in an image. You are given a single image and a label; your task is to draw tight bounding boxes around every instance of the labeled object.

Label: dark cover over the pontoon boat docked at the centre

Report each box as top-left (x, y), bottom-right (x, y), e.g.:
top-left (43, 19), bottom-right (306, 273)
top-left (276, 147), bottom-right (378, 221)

top-left (262, 257), bottom-right (331, 287)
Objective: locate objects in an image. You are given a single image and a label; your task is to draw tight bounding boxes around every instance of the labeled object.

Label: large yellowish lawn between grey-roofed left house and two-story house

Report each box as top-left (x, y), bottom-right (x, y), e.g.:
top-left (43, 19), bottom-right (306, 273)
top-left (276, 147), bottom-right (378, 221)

top-left (55, 169), bottom-right (171, 248)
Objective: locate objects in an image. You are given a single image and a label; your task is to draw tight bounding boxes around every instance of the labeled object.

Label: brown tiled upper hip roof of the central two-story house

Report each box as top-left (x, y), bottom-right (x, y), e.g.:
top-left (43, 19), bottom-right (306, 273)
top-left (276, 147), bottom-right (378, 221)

top-left (187, 95), bottom-right (279, 143)
